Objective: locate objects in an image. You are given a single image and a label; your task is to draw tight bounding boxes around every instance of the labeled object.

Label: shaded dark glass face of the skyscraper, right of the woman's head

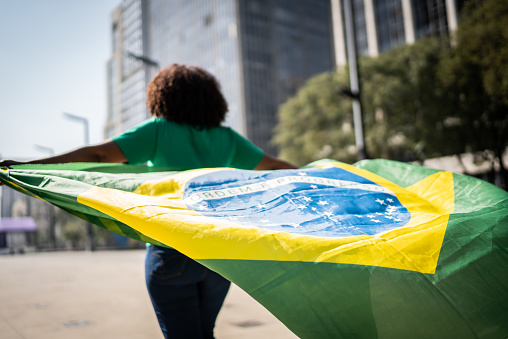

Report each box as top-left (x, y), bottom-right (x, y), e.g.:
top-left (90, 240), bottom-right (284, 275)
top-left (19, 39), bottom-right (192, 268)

top-left (237, 0), bottom-right (334, 151)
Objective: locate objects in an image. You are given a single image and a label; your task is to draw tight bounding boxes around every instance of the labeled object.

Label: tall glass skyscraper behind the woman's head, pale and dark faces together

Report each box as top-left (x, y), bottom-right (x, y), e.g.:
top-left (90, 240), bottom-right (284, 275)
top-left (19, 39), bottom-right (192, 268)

top-left (105, 0), bottom-right (335, 153)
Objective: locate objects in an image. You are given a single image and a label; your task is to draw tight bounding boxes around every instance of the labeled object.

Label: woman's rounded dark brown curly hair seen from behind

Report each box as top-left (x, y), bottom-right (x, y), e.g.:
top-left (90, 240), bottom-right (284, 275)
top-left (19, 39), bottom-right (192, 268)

top-left (146, 64), bottom-right (228, 128)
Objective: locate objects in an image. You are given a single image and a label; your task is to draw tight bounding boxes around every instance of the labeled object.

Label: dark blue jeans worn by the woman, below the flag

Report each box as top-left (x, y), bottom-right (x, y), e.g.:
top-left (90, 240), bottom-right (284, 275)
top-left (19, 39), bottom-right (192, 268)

top-left (145, 245), bottom-right (230, 339)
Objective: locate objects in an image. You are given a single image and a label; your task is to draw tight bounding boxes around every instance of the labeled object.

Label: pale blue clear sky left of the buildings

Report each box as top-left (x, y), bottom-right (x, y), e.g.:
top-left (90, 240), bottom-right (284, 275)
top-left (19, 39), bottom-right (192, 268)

top-left (0, 0), bottom-right (121, 160)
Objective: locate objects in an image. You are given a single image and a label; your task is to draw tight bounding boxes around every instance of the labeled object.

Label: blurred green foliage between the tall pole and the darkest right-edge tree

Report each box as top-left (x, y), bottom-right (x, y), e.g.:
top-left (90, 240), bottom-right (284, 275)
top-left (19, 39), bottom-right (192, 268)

top-left (360, 38), bottom-right (450, 161)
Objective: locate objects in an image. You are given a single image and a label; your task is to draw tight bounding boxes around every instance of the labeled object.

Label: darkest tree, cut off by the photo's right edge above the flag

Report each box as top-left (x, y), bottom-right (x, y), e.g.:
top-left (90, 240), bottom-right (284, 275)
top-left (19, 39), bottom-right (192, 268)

top-left (440, 0), bottom-right (508, 183)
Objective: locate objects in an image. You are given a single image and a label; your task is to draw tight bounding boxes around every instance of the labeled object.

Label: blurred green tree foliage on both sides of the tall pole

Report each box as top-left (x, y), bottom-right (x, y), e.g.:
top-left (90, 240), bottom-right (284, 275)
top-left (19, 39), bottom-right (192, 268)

top-left (273, 39), bottom-right (445, 164)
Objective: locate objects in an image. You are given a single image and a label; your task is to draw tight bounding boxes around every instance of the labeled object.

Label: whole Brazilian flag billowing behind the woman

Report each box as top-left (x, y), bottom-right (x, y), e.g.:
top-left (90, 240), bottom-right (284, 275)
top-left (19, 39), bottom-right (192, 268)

top-left (0, 160), bottom-right (508, 339)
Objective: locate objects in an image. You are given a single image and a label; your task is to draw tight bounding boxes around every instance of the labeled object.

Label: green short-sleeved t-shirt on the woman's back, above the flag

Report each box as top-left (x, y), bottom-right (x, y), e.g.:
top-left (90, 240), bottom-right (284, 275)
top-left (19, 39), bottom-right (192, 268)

top-left (113, 117), bottom-right (263, 170)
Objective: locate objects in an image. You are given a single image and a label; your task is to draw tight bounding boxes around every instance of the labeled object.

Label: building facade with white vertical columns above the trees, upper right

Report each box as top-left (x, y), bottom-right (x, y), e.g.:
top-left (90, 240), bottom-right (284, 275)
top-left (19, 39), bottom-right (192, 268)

top-left (331, 0), bottom-right (465, 65)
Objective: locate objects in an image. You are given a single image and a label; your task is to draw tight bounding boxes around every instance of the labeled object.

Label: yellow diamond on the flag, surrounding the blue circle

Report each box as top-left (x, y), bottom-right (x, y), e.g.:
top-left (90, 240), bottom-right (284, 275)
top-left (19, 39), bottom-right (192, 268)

top-left (78, 163), bottom-right (454, 273)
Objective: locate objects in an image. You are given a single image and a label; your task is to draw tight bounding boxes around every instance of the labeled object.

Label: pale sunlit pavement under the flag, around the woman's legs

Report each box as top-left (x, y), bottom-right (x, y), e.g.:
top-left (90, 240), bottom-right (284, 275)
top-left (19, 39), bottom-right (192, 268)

top-left (0, 250), bottom-right (297, 339)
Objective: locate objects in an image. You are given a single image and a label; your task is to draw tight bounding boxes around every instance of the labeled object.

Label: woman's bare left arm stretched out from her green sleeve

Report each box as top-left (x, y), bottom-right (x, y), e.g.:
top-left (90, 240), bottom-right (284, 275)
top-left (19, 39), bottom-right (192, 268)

top-left (0, 140), bottom-right (127, 166)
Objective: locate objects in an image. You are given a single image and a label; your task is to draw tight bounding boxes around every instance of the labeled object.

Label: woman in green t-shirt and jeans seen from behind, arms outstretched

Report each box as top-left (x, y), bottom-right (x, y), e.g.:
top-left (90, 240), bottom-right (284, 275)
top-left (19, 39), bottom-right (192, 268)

top-left (0, 64), bottom-right (296, 338)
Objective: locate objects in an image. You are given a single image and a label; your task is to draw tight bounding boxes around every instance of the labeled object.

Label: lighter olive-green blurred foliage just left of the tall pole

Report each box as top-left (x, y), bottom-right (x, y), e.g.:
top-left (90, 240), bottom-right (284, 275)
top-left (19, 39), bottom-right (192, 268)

top-left (273, 71), bottom-right (356, 165)
